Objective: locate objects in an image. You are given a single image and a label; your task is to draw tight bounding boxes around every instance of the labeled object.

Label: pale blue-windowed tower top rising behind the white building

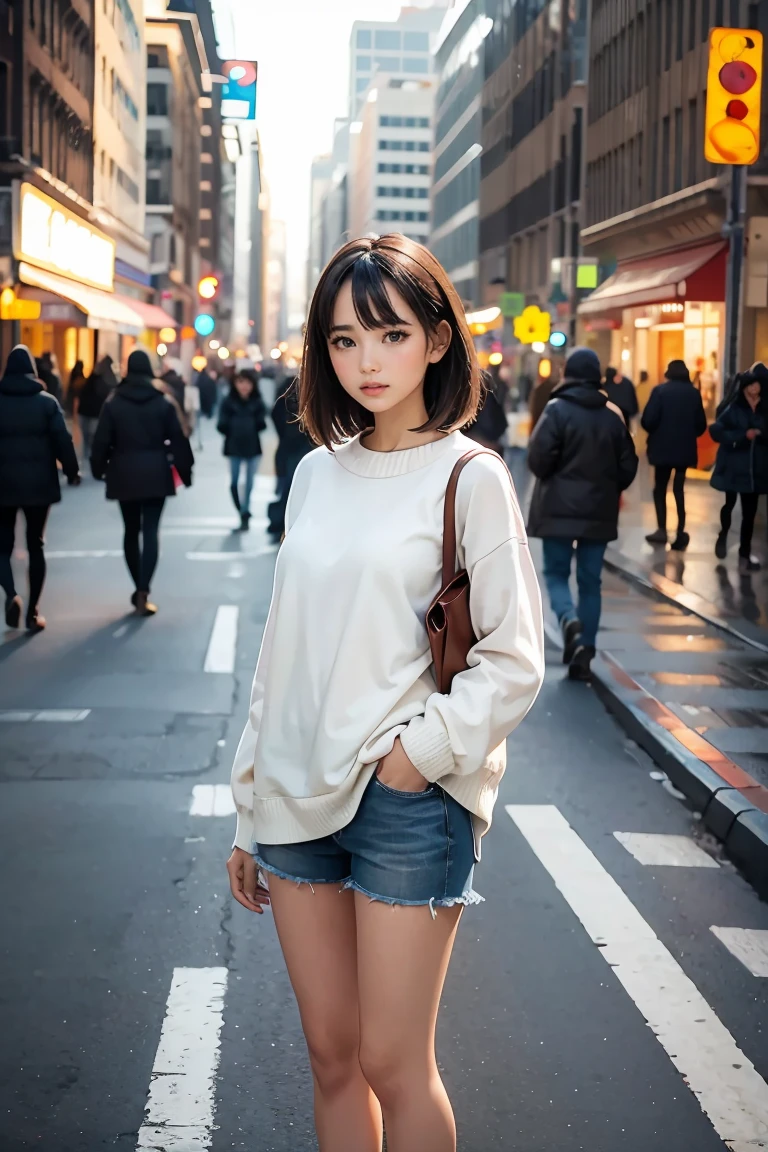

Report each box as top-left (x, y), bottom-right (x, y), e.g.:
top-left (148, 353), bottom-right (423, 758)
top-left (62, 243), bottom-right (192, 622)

top-left (349, 3), bottom-right (448, 120)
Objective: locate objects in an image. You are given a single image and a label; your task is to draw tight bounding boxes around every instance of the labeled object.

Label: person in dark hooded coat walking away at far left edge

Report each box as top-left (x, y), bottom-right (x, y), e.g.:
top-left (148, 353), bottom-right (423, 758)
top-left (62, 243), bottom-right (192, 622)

top-left (0, 344), bottom-right (79, 631)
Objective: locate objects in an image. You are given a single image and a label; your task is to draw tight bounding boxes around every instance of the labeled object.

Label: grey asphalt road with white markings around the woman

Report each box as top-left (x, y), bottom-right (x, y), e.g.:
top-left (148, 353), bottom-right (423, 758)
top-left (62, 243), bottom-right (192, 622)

top-left (0, 426), bottom-right (768, 1152)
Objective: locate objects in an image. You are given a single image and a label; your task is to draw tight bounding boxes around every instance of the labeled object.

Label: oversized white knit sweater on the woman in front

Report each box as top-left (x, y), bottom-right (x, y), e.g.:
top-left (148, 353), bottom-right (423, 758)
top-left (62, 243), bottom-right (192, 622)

top-left (231, 432), bottom-right (543, 857)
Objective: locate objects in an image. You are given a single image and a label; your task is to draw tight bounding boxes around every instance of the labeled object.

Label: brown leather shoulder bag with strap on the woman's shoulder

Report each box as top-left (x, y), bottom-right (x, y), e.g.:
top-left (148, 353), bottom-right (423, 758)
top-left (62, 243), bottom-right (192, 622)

top-left (426, 448), bottom-right (501, 694)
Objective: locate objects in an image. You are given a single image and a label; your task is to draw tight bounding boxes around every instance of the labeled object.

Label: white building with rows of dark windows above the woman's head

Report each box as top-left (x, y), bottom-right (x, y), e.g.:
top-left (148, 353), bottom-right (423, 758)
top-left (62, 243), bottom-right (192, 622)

top-left (349, 73), bottom-right (435, 244)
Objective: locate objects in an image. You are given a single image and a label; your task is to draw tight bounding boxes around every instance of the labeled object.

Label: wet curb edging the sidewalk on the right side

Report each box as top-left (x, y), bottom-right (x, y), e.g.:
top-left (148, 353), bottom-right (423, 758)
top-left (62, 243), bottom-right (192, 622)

top-left (592, 652), bottom-right (768, 897)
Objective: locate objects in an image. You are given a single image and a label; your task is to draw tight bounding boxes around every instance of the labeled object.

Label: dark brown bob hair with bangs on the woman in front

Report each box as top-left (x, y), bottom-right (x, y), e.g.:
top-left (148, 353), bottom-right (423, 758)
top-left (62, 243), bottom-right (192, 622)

top-left (299, 233), bottom-right (481, 449)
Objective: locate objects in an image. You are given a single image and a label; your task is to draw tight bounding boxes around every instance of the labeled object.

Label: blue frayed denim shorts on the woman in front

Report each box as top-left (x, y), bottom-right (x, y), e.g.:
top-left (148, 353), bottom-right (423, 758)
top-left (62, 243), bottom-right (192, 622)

top-left (253, 775), bottom-right (482, 917)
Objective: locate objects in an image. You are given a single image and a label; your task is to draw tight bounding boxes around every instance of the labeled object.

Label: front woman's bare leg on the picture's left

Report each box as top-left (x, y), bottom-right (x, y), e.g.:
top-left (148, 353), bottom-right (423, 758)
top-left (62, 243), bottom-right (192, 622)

top-left (268, 876), bottom-right (382, 1152)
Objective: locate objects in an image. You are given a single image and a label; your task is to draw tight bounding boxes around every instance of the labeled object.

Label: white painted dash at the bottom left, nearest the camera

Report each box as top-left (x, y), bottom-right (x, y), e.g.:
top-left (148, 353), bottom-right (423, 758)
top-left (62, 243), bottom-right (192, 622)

top-left (136, 968), bottom-right (227, 1152)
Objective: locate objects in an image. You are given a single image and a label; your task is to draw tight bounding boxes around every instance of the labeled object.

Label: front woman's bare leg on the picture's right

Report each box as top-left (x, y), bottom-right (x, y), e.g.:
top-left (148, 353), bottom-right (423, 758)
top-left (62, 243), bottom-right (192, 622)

top-left (355, 893), bottom-right (463, 1152)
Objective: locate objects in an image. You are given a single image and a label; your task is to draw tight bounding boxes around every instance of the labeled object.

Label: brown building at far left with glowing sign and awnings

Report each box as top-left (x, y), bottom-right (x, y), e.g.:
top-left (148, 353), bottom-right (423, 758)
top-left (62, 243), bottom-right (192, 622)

top-left (0, 0), bottom-right (156, 381)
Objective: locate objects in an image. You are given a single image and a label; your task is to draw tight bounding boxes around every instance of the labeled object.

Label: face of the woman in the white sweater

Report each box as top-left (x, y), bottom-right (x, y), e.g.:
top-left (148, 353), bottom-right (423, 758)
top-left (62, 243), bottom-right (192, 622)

top-left (328, 280), bottom-right (451, 414)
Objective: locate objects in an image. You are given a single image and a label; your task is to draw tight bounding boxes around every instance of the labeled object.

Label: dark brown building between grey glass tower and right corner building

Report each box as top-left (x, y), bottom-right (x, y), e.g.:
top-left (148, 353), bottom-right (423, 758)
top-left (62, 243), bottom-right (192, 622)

top-left (479, 0), bottom-right (589, 335)
